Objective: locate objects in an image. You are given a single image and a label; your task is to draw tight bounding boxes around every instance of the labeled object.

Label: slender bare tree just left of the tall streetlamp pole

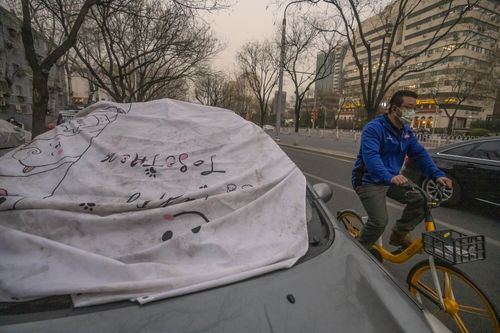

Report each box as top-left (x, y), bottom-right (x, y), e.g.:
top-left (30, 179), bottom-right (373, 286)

top-left (237, 41), bottom-right (278, 126)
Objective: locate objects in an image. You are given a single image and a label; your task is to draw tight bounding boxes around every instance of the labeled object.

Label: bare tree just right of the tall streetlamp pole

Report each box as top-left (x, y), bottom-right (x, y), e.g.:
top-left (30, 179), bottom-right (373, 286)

top-left (285, 16), bottom-right (338, 132)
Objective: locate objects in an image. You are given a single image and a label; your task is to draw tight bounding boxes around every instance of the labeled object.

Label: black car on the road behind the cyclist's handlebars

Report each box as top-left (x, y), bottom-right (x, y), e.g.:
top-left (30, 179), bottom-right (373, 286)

top-left (403, 137), bottom-right (500, 207)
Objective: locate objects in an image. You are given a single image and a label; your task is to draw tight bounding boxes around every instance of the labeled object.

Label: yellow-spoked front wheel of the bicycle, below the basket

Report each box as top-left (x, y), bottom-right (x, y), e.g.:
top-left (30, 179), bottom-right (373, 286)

top-left (407, 261), bottom-right (500, 333)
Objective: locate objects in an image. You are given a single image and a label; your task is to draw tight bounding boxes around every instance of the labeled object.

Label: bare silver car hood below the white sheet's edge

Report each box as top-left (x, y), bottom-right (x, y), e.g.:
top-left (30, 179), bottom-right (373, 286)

top-left (0, 230), bottom-right (438, 333)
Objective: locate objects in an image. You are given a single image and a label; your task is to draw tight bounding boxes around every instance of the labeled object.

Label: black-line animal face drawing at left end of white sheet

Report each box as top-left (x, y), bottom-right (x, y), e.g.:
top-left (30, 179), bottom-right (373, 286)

top-left (0, 106), bottom-right (130, 198)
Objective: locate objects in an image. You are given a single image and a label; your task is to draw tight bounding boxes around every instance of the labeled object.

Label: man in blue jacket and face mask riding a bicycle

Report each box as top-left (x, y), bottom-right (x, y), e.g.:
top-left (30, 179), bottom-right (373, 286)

top-left (352, 90), bottom-right (452, 249)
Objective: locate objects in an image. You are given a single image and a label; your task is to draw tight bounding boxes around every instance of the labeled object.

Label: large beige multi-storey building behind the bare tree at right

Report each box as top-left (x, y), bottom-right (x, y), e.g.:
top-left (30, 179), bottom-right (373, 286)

top-left (342, 0), bottom-right (500, 129)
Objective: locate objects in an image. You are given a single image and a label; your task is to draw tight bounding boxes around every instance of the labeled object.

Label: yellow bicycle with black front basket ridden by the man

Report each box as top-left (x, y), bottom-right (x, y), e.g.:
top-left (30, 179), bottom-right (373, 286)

top-left (337, 186), bottom-right (500, 333)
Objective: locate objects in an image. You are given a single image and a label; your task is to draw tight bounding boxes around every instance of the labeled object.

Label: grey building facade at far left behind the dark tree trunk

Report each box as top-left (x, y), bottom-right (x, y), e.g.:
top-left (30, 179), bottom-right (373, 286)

top-left (0, 7), bottom-right (68, 130)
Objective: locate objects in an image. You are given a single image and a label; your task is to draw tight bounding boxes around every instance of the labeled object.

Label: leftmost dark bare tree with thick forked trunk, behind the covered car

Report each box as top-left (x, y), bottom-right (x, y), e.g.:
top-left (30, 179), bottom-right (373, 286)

top-left (21, 0), bottom-right (106, 136)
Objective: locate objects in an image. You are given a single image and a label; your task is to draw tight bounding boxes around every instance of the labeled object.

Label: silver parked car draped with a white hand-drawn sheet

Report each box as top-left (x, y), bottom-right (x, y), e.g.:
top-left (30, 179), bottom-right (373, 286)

top-left (0, 100), bottom-right (447, 333)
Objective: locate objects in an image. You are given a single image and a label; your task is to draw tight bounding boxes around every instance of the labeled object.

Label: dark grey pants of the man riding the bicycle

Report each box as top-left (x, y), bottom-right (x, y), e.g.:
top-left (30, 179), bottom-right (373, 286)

top-left (356, 185), bottom-right (425, 249)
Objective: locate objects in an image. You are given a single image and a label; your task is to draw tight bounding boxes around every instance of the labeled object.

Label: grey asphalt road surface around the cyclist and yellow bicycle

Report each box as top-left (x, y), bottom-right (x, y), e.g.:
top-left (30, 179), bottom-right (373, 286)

top-left (282, 146), bottom-right (500, 309)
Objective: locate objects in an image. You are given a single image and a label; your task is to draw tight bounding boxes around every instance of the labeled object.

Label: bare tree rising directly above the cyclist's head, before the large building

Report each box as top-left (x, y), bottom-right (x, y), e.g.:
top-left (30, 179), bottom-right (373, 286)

top-left (316, 0), bottom-right (478, 119)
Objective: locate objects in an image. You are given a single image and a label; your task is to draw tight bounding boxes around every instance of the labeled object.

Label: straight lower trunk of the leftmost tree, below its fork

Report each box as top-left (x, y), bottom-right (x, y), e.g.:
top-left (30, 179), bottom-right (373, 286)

top-left (31, 73), bottom-right (49, 138)
